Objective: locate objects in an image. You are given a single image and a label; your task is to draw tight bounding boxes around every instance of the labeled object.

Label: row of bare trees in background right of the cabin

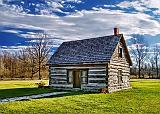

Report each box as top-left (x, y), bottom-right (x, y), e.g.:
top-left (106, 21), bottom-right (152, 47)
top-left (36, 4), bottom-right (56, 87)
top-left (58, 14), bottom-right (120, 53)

top-left (130, 35), bottom-right (160, 78)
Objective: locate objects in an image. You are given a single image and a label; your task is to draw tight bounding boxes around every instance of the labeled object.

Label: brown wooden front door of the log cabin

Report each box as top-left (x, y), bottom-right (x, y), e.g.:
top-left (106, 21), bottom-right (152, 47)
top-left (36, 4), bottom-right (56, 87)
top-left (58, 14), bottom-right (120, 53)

top-left (73, 70), bottom-right (81, 88)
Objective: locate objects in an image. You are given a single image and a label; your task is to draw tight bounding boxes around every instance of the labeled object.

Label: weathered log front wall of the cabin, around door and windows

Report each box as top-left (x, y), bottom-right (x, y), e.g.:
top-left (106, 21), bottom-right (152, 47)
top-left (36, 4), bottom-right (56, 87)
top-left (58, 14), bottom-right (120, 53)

top-left (49, 65), bottom-right (106, 90)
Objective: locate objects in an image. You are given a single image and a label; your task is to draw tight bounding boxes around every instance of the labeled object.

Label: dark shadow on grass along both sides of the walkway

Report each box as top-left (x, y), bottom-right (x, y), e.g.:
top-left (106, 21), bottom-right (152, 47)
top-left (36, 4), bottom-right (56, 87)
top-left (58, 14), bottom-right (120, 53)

top-left (0, 88), bottom-right (99, 99)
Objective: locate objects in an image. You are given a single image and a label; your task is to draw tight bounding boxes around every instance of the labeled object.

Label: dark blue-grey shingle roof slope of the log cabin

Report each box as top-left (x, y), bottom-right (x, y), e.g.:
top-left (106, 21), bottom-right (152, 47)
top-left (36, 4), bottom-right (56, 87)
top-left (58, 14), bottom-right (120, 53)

top-left (48, 35), bottom-right (121, 65)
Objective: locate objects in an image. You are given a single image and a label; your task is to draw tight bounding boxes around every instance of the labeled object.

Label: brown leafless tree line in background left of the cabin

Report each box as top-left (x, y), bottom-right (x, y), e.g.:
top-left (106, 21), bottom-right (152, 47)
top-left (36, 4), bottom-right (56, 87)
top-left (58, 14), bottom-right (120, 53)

top-left (0, 34), bottom-right (50, 79)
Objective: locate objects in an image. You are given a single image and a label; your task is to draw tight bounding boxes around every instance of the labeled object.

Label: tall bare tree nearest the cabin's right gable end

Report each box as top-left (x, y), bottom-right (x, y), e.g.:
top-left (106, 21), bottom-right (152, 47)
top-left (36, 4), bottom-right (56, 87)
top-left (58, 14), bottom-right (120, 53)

top-left (131, 35), bottom-right (148, 78)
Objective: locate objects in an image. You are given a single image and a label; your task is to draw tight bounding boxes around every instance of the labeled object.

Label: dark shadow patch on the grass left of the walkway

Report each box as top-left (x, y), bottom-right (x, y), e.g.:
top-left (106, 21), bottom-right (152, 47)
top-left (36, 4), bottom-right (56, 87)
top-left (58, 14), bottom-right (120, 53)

top-left (0, 88), bottom-right (54, 99)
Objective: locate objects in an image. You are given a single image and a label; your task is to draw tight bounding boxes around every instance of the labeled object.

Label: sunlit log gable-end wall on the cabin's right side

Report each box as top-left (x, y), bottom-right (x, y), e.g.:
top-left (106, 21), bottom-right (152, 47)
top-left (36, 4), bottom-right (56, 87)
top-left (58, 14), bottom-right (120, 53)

top-left (108, 43), bottom-right (130, 92)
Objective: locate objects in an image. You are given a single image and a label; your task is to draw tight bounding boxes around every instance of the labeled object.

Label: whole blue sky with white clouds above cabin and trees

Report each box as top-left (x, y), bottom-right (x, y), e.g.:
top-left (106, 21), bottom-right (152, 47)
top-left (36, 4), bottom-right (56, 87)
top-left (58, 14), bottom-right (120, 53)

top-left (0, 0), bottom-right (160, 50)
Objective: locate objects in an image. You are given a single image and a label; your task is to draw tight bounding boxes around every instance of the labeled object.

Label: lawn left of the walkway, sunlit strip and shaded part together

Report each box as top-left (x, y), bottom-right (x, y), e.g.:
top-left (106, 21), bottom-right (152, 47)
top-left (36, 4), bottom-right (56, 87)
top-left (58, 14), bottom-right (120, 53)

top-left (0, 80), bottom-right (53, 99)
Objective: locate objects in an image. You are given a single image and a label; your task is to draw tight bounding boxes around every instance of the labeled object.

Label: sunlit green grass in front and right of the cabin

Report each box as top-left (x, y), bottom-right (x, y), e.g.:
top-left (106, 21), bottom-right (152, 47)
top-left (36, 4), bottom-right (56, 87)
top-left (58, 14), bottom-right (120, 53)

top-left (0, 80), bottom-right (160, 114)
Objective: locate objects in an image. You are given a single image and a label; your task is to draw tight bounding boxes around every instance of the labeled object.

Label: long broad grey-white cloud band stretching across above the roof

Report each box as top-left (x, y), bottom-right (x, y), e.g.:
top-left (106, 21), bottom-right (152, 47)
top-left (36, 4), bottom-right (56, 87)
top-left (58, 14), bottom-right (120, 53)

top-left (0, 2), bottom-right (160, 49)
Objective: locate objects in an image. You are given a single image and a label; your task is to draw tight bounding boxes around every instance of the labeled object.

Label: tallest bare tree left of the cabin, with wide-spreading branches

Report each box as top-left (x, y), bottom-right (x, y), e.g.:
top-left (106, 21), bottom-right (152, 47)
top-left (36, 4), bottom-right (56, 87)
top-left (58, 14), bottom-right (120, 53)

top-left (27, 33), bottom-right (50, 79)
